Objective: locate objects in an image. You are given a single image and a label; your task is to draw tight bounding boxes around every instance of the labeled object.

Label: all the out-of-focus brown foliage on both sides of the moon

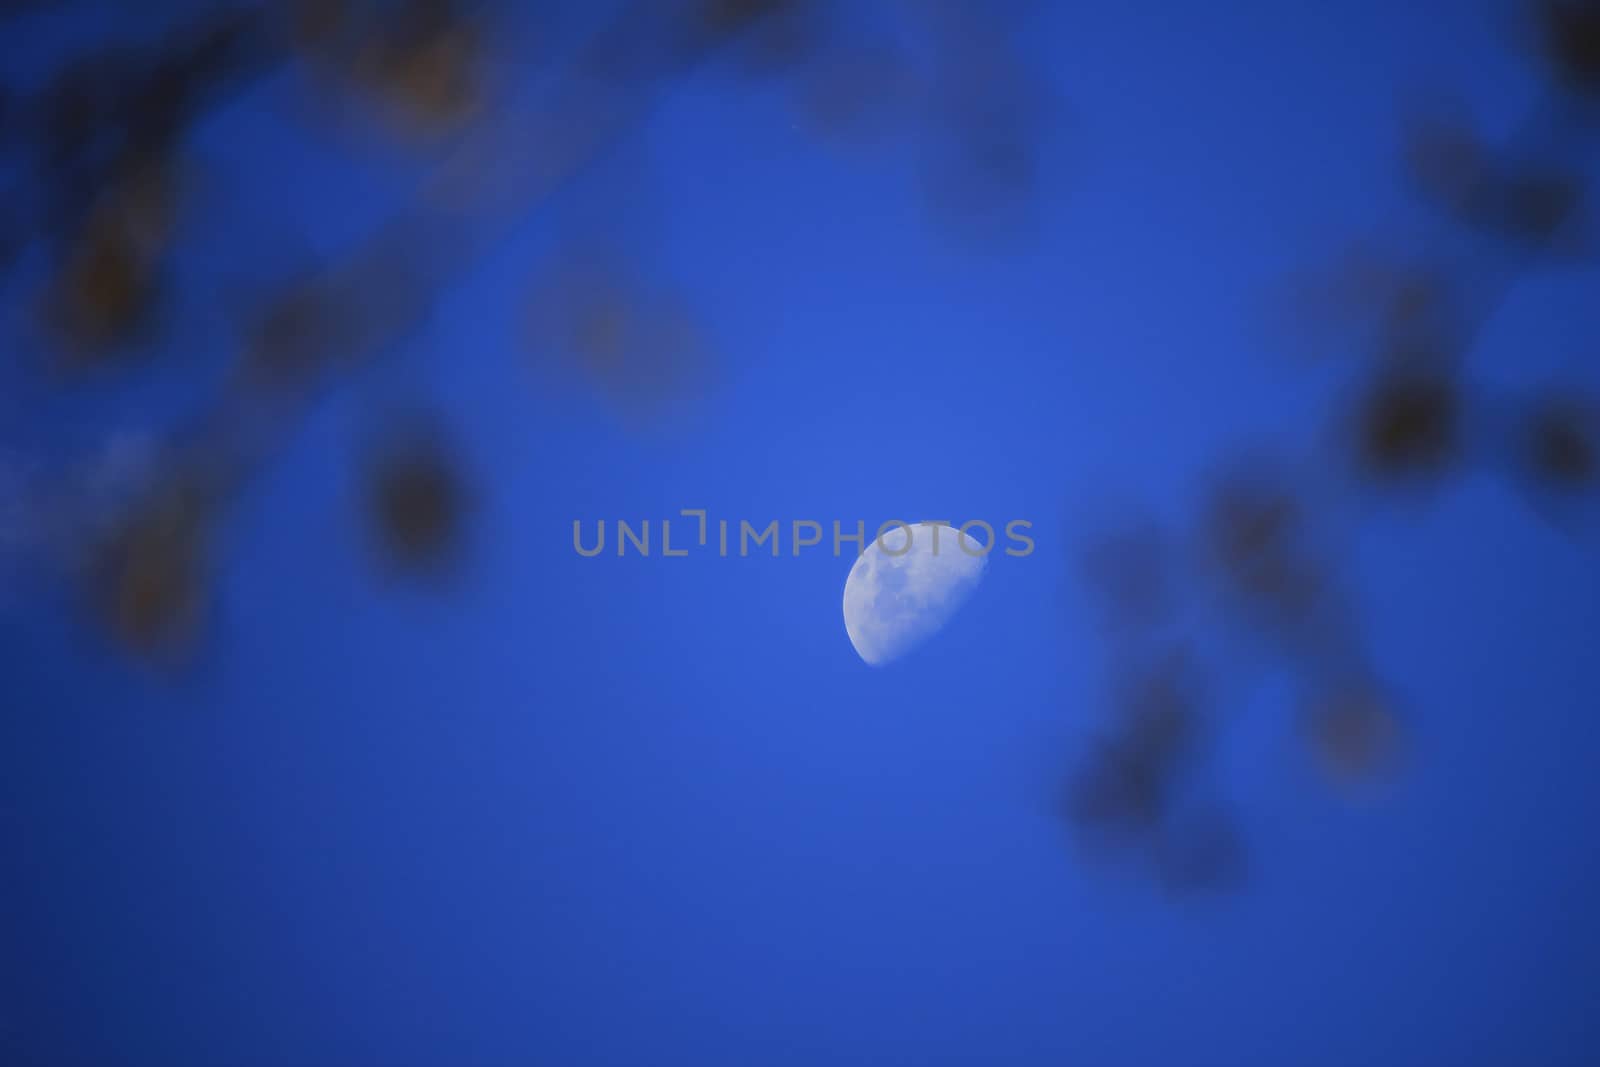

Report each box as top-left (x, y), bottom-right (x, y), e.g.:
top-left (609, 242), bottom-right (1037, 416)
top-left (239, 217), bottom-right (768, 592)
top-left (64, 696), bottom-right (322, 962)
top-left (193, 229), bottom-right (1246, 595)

top-left (0, 0), bottom-right (1600, 891)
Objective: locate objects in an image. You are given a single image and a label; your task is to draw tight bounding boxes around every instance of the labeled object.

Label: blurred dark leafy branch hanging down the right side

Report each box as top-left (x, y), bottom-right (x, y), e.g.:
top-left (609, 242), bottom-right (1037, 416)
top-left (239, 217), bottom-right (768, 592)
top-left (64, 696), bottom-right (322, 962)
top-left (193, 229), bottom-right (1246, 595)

top-left (1066, 0), bottom-right (1600, 889)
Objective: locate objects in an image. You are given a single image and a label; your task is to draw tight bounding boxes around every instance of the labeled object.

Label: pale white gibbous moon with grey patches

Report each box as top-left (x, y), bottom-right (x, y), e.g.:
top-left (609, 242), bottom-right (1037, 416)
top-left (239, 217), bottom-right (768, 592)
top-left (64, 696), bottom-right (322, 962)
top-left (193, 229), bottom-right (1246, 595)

top-left (845, 523), bottom-right (987, 667)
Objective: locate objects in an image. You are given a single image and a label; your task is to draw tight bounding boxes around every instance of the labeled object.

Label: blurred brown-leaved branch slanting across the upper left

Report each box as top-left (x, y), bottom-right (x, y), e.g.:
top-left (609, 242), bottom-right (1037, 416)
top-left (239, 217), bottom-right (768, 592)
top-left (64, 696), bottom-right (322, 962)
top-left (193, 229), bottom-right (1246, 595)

top-left (5, 0), bottom-right (1062, 662)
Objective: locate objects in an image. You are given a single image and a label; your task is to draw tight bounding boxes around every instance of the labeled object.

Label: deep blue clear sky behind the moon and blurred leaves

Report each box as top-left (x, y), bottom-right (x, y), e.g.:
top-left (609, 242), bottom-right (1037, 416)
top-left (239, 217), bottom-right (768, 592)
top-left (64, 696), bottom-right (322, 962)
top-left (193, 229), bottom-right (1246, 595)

top-left (0, 2), bottom-right (1600, 1067)
